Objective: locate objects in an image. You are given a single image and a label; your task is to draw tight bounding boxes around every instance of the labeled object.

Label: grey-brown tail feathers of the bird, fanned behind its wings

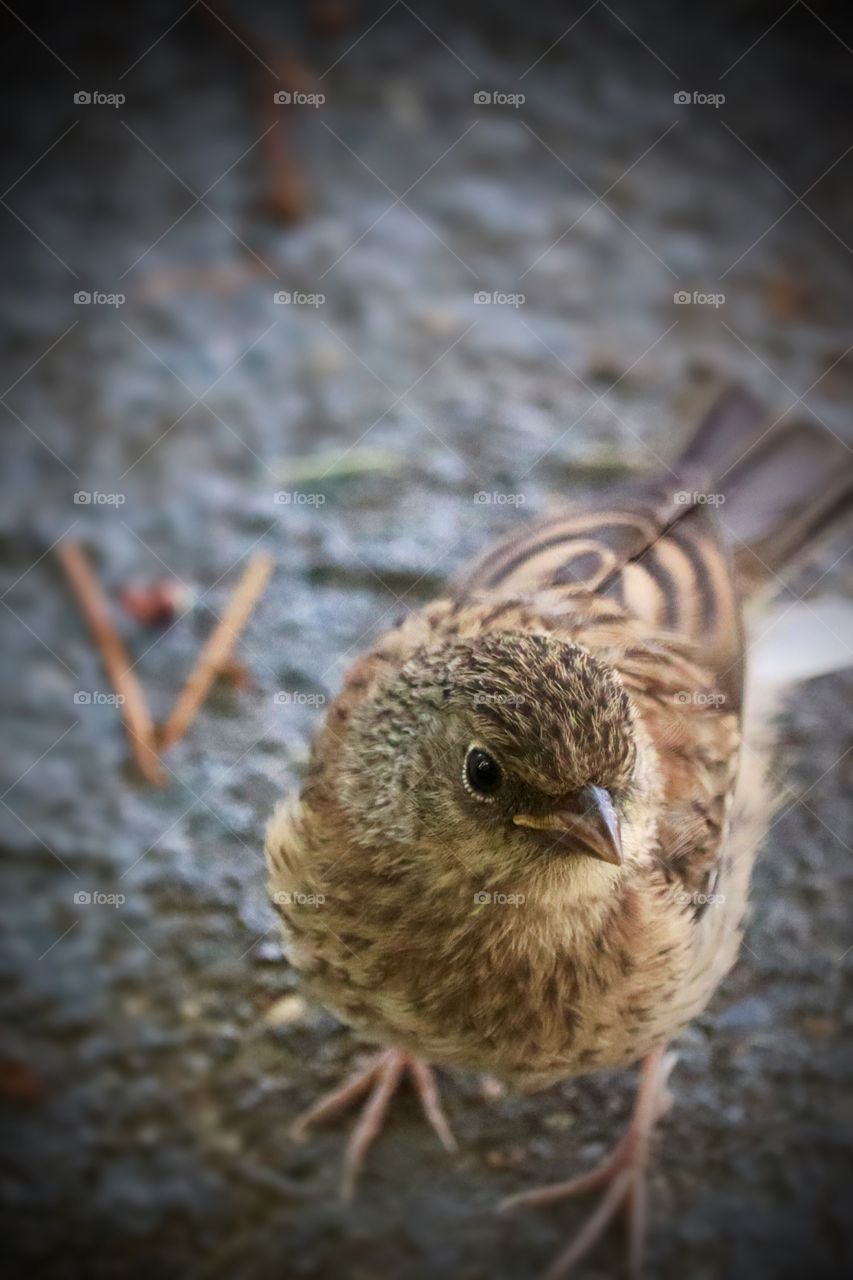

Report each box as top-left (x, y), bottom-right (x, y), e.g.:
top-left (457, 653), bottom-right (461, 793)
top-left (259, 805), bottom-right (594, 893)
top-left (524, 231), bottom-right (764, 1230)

top-left (679, 387), bottom-right (853, 596)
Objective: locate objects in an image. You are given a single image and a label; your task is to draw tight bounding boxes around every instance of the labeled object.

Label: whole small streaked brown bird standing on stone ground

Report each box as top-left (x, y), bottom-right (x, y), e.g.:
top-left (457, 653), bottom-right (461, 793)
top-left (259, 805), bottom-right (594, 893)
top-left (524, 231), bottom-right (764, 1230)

top-left (266, 389), bottom-right (852, 1280)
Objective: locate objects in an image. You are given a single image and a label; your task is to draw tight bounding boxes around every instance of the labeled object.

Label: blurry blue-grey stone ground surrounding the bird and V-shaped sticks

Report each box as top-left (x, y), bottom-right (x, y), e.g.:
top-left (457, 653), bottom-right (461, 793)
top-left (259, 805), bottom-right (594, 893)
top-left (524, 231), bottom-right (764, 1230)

top-left (0, 0), bottom-right (853, 1280)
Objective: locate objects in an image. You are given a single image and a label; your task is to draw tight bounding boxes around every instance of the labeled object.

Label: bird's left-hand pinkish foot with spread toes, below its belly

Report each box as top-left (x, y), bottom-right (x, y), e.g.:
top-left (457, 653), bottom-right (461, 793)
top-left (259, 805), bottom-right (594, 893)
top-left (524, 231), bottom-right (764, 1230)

top-left (289, 1048), bottom-right (457, 1201)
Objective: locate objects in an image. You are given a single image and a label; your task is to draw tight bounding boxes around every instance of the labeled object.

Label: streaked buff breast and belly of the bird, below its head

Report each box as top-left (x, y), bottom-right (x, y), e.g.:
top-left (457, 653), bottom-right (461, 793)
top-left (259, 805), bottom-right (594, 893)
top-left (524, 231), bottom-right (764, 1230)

top-left (273, 855), bottom-right (732, 1085)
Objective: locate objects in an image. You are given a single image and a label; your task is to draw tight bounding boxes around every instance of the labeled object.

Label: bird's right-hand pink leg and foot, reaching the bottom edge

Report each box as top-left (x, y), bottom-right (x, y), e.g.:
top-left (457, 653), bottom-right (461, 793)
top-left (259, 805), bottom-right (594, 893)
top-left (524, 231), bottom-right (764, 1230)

top-left (500, 1048), bottom-right (675, 1280)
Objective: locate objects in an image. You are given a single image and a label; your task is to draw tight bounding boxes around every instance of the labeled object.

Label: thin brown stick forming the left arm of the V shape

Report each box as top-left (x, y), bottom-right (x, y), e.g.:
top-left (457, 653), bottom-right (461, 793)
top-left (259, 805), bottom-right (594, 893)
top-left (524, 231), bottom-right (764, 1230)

top-left (56, 541), bottom-right (167, 786)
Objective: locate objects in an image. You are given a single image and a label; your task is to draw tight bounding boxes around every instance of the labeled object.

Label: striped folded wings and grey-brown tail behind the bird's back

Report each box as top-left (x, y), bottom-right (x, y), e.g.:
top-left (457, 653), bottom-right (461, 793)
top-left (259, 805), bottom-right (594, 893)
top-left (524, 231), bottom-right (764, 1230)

top-left (456, 387), bottom-right (853, 709)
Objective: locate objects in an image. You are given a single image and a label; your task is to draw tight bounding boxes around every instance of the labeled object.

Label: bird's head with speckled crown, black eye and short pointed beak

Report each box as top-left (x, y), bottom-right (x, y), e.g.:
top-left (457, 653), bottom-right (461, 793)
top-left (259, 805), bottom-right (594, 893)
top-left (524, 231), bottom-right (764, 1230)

top-left (275, 632), bottom-right (642, 893)
